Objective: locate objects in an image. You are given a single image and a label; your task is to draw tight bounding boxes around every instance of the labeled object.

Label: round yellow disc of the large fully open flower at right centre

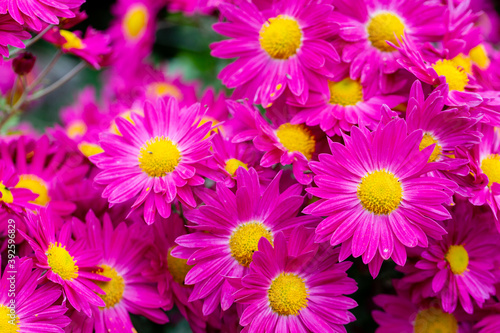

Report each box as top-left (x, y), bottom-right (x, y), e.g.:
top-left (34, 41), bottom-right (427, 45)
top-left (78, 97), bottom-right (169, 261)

top-left (357, 169), bottom-right (403, 215)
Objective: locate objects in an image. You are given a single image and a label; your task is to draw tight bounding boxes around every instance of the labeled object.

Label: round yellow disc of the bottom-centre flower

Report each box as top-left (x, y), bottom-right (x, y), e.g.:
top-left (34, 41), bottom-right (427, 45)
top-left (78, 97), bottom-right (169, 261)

top-left (267, 273), bottom-right (308, 316)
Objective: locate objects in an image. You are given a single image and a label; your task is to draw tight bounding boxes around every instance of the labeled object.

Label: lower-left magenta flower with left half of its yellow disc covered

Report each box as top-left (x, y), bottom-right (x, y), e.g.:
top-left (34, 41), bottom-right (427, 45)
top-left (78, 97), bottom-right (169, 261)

top-left (73, 211), bottom-right (168, 333)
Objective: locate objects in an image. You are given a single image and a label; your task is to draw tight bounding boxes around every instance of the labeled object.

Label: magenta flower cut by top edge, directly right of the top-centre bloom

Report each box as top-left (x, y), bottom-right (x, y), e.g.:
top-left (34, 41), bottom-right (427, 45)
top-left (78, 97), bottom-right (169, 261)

top-left (332, 0), bottom-right (446, 79)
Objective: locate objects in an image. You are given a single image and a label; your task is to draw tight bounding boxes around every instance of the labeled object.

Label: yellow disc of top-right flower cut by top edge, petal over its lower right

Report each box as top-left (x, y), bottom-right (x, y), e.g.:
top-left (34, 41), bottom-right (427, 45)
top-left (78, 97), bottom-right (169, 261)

top-left (366, 13), bottom-right (405, 52)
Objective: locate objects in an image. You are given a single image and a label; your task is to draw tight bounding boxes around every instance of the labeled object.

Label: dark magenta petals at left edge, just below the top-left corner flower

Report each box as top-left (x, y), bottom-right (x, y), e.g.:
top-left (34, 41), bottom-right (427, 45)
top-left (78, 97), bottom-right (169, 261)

top-left (0, 13), bottom-right (31, 57)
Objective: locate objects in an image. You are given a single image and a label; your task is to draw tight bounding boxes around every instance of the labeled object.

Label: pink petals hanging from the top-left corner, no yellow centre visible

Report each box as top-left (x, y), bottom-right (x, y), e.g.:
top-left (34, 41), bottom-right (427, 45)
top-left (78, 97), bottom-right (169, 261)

top-left (0, 0), bottom-right (85, 31)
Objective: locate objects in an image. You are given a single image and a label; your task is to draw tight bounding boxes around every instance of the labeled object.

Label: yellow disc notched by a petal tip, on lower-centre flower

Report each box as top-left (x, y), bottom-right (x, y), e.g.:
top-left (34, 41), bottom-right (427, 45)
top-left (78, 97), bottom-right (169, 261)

top-left (229, 222), bottom-right (273, 267)
